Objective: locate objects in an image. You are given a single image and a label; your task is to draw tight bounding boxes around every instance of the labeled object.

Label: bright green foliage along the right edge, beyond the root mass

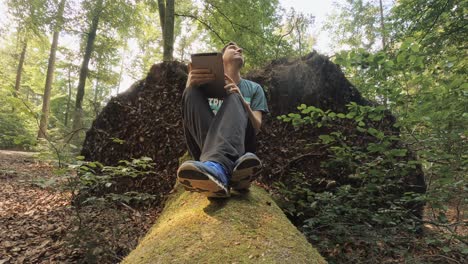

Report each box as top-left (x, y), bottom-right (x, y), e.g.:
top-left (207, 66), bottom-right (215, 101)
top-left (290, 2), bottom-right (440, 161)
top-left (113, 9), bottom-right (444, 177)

top-left (335, 1), bottom-right (468, 250)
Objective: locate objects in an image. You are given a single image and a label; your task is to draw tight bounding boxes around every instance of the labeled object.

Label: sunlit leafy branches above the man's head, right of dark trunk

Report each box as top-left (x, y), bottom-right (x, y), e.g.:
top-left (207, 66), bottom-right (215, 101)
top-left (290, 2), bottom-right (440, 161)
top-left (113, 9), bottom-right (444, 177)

top-left (178, 0), bottom-right (313, 70)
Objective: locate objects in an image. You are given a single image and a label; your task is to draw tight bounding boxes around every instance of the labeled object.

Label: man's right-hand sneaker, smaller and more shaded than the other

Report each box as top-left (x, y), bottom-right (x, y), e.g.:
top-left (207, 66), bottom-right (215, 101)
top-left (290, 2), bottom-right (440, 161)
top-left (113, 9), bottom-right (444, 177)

top-left (231, 152), bottom-right (262, 190)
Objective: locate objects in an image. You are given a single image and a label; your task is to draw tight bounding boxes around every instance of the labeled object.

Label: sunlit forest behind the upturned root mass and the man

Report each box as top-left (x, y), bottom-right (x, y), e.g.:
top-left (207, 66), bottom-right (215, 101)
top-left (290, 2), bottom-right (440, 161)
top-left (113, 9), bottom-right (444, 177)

top-left (0, 0), bottom-right (468, 262)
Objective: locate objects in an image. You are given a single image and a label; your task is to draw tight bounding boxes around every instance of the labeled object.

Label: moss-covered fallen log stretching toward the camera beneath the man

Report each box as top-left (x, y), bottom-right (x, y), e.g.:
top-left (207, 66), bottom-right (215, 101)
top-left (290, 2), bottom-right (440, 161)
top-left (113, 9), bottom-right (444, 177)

top-left (123, 186), bottom-right (326, 264)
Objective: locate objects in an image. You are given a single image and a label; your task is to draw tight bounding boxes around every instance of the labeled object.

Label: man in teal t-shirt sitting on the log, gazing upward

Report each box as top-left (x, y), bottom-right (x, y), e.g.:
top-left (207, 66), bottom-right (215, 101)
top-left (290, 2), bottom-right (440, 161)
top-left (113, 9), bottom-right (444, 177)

top-left (177, 42), bottom-right (268, 197)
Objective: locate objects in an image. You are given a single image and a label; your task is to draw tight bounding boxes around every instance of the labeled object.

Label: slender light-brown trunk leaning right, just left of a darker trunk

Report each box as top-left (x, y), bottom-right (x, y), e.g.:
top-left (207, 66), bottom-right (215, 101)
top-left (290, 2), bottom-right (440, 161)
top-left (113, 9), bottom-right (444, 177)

top-left (37, 0), bottom-right (65, 138)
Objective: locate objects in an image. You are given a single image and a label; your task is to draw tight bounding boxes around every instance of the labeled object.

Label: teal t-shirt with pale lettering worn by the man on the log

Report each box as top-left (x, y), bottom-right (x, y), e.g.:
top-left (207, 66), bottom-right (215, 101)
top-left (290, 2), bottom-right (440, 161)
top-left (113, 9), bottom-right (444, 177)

top-left (208, 79), bottom-right (269, 114)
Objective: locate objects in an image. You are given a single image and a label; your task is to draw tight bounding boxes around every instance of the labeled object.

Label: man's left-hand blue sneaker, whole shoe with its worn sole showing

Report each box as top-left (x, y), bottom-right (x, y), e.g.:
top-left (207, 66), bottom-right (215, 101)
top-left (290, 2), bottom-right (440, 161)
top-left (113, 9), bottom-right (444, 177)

top-left (177, 161), bottom-right (230, 198)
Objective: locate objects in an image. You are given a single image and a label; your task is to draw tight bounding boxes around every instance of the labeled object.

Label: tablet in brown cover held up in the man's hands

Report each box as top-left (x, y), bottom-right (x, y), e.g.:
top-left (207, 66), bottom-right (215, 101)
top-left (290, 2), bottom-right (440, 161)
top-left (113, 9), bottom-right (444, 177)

top-left (192, 52), bottom-right (227, 98)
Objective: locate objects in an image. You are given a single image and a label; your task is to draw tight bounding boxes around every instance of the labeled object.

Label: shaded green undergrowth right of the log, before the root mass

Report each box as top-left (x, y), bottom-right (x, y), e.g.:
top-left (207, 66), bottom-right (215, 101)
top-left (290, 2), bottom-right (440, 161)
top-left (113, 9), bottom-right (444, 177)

top-left (274, 103), bottom-right (468, 263)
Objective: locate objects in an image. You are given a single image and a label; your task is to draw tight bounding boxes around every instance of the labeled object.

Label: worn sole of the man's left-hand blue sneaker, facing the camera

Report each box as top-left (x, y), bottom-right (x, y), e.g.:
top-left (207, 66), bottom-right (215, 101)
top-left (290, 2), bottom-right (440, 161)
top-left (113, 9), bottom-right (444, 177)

top-left (177, 163), bottom-right (230, 198)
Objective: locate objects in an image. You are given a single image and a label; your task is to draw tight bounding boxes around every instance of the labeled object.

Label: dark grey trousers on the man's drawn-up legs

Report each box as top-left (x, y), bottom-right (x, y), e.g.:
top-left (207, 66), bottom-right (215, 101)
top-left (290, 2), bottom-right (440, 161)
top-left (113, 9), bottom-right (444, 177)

top-left (182, 88), bottom-right (256, 165)
